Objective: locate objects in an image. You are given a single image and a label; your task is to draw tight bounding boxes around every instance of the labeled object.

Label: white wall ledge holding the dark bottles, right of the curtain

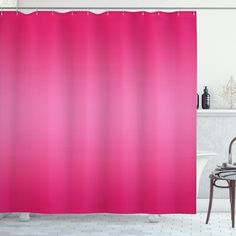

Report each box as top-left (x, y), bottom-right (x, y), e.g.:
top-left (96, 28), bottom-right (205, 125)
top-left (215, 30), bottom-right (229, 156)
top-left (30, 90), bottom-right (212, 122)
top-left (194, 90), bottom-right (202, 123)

top-left (197, 109), bottom-right (236, 117)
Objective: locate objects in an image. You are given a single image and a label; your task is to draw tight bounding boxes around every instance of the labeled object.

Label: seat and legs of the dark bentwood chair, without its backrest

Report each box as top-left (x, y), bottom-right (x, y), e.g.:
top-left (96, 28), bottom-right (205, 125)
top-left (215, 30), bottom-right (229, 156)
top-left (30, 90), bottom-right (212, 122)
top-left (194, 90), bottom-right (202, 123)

top-left (206, 171), bottom-right (236, 228)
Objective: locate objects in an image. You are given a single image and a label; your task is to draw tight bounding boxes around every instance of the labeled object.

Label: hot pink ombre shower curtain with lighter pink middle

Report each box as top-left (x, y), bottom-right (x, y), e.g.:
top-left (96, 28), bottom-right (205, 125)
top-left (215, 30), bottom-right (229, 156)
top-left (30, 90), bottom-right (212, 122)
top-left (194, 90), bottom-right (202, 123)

top-left (0, 11), bottom-right (197, 214)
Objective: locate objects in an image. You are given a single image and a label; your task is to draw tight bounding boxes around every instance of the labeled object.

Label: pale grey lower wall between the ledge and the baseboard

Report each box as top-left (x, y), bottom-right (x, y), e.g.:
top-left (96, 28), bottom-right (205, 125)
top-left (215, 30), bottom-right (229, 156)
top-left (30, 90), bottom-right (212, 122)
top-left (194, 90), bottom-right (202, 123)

top-left (197, 114), bottom-right (236, 198)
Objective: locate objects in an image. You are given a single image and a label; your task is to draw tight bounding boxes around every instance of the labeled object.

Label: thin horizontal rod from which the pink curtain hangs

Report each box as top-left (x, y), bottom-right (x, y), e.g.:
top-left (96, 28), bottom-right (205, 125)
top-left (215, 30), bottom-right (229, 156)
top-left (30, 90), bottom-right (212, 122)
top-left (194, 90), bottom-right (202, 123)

top-left (0, 6), bottom-right (236, 11)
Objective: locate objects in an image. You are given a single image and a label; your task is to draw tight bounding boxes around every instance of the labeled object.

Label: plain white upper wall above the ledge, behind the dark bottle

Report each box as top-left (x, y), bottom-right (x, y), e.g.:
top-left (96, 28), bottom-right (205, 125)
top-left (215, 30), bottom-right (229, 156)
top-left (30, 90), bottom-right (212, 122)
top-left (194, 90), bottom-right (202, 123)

top-left (197, 10), bottom-right (236, 108)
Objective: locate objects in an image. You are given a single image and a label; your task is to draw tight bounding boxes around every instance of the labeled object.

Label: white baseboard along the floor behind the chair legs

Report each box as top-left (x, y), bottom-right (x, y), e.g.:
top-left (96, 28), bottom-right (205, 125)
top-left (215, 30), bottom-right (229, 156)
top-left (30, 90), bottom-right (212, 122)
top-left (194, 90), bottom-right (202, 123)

top-left (197, 199), bottom-right (230, 212)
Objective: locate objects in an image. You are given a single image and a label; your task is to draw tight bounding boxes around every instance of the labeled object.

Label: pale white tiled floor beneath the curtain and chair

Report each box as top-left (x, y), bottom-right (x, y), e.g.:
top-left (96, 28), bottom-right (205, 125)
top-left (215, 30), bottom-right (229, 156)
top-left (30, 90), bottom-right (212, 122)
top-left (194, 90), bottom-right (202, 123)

top-left (0, 213), bottom-right (236, 236)
